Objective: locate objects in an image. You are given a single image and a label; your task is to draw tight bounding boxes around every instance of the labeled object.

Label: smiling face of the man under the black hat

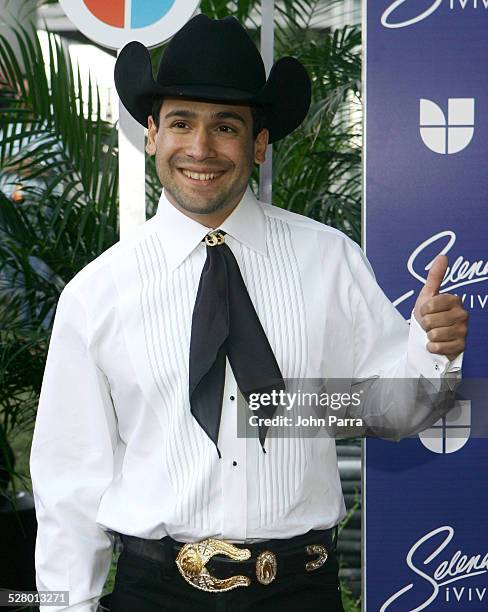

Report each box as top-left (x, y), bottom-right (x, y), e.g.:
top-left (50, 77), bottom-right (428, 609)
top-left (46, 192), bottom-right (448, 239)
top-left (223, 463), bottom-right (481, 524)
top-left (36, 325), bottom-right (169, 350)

top-left (146, 98), bottom-right (268, 224)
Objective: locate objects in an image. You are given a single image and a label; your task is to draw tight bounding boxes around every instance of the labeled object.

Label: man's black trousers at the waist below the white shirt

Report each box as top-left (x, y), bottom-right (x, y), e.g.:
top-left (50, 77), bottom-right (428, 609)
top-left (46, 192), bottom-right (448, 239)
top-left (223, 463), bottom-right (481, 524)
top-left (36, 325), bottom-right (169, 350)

top-left (110, 536), bottom-right (344, 612)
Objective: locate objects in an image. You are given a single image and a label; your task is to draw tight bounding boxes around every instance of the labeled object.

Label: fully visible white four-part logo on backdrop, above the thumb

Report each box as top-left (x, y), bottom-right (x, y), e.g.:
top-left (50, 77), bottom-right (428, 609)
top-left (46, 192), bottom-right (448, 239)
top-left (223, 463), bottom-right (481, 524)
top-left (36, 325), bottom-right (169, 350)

top-left (420, 98), bottom-right (474, 155)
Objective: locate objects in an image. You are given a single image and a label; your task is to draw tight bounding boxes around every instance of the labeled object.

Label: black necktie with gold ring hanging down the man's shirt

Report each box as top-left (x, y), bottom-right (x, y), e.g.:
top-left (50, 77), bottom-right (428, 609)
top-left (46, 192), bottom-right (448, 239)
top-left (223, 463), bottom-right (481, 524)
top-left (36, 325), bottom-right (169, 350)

top-left (189, 230), bottom-right (285, 457)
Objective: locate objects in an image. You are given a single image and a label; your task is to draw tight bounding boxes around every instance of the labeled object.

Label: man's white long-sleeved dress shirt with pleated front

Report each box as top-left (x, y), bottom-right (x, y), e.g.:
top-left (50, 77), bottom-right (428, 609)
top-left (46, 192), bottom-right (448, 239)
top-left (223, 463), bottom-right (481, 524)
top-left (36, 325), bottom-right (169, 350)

top-left (30, 190), bottom-right (460, 612)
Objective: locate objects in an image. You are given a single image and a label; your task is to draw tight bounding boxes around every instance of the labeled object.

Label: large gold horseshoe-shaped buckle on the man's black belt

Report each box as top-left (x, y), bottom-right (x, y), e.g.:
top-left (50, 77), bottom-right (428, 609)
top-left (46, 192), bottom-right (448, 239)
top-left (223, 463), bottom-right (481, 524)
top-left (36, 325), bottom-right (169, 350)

top-left (176, 538), bottom-right (251, 593)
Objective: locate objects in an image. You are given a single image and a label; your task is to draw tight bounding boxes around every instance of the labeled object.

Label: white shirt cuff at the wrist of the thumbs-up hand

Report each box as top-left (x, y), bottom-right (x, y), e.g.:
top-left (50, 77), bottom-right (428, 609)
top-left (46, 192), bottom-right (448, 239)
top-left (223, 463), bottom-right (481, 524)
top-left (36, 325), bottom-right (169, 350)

top-left (407, 312), bottom-right (464, 378)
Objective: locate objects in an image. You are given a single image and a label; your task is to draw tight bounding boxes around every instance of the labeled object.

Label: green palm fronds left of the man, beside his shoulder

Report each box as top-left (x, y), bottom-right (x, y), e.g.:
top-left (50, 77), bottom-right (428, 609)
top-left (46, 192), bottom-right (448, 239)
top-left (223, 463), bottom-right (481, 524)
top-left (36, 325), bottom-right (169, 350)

top-left (0, 28), bottom-right (118, 492)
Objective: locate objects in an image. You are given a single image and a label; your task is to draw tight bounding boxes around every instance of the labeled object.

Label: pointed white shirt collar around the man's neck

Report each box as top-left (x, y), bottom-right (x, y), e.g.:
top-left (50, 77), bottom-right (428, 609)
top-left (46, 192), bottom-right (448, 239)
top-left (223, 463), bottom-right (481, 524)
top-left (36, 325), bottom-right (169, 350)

top-left (155, 187), bottom-right (267, 271)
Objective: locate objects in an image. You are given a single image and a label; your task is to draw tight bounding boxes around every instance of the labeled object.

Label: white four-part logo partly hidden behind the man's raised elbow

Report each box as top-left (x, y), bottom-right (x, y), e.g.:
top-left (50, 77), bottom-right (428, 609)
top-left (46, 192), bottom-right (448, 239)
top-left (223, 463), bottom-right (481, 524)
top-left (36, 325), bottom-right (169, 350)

top-left (419, 400), bottom-right (471, 455)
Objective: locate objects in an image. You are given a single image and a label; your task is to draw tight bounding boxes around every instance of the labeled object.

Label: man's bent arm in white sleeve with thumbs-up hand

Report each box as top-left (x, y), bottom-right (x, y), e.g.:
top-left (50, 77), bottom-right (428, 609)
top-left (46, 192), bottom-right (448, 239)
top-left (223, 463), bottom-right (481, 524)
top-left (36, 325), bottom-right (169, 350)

top-left (346, 244), bottom-right (466, 439)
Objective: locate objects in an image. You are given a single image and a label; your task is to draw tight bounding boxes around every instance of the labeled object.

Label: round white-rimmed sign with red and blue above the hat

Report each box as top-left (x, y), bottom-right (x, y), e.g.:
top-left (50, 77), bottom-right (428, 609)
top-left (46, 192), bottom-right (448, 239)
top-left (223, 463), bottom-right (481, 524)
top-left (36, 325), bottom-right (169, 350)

top-left (60, 0), bottom-right (199, 49)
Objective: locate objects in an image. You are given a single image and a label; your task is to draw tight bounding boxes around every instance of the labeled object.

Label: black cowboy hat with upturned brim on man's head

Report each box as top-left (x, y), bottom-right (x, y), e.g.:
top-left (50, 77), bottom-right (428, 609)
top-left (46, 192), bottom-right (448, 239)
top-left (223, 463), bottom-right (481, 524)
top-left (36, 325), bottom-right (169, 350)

top-left (115, 15), bottom-right (311, 142)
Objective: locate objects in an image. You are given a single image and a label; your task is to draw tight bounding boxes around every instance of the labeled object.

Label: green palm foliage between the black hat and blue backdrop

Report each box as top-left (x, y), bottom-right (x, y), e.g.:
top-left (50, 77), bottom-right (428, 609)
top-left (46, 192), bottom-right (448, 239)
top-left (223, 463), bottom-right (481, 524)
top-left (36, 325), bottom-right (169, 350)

top-left (273, 19), bottom-right (361, 242)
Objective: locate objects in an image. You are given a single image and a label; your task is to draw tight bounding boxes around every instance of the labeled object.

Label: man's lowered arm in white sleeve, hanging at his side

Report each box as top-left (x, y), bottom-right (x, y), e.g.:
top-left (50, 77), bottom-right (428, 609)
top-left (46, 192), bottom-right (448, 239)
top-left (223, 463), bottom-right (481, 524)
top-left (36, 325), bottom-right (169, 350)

top-left (30, 285), bottom-right (117, 612)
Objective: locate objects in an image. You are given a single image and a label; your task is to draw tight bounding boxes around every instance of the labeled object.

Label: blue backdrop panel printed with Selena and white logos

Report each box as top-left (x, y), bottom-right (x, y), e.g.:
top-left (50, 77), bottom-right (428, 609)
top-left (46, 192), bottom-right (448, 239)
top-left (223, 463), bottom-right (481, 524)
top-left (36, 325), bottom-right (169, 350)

top-left (363, 0), bottom-right (488, 612)
